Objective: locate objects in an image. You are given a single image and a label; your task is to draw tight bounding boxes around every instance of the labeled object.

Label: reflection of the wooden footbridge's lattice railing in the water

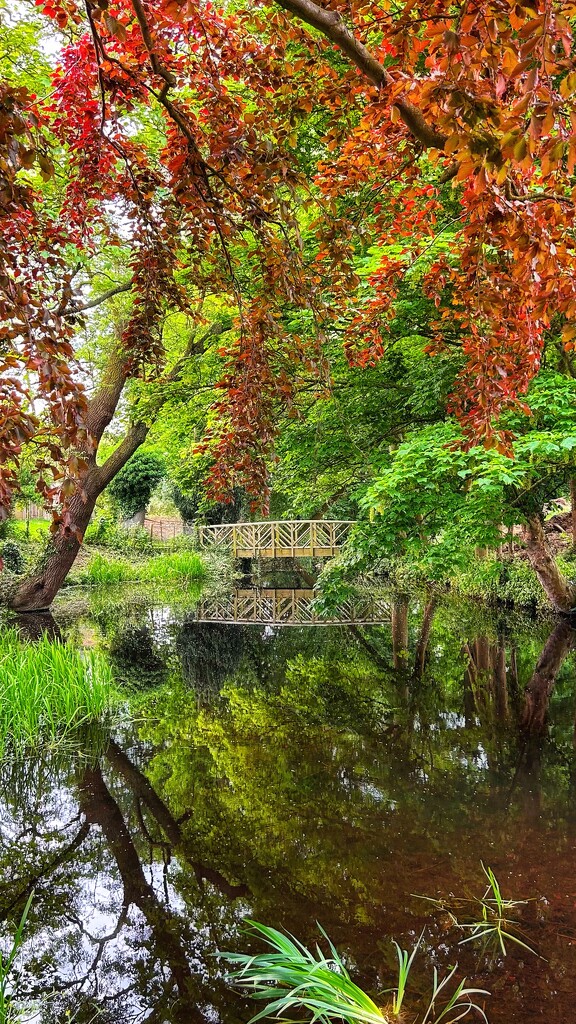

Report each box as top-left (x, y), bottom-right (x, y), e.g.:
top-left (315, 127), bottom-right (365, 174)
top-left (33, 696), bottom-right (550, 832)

top-left (196, 587), bottom-right (392, 626)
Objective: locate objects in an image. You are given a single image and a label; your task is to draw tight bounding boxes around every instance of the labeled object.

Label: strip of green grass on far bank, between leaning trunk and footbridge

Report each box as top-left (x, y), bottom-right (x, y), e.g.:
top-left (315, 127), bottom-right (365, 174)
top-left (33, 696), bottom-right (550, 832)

top-left (78, 551), bottom-right (206, 586)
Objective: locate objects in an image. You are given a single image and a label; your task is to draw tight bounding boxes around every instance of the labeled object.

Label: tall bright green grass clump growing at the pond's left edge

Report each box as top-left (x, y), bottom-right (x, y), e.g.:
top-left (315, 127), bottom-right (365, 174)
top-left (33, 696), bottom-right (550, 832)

top-left (0, 630), bottom-right (114, 756)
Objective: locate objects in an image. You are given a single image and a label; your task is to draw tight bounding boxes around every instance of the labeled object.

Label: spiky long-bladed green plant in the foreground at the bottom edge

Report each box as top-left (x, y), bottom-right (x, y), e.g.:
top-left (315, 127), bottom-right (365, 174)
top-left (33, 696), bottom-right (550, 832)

top-left (220, 921), bottom-right (488, 1024)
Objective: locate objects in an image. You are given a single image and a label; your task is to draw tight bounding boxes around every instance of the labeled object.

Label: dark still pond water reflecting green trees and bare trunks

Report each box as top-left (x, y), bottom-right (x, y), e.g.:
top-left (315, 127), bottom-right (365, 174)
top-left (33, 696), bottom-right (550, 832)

top-left (0, 594), bottom-right (576, 1024)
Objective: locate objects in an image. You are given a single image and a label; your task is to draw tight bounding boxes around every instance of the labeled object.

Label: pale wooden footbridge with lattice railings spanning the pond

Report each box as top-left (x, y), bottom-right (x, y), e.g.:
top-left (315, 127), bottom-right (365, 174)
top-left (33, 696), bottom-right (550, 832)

top-left (198, 519), bottom-right (354, 558)
